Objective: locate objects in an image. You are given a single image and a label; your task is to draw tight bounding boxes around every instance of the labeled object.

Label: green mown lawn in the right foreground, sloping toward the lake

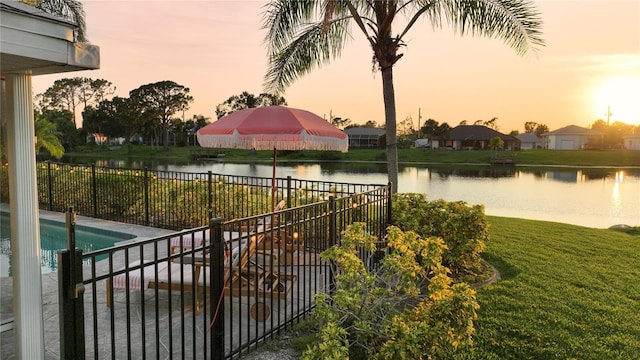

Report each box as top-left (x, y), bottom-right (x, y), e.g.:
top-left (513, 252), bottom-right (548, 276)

top-left (473, 216), bottom-right (640, 360)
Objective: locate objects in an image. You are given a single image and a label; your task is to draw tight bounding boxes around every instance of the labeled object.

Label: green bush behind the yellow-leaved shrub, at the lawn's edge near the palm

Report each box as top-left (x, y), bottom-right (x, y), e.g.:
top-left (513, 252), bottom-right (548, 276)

top-left (392, 193), bottom-right (489, 278)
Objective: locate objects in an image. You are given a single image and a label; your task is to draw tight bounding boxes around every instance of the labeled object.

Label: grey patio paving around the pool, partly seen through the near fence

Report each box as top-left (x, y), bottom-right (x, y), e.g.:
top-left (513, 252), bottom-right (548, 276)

top-left (0, 210), bottom-right (324, 359)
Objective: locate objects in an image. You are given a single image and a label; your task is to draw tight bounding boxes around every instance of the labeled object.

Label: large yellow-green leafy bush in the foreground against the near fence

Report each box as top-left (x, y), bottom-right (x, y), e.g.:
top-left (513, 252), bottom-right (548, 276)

top-left (302, 223), bottom-right (478, 360)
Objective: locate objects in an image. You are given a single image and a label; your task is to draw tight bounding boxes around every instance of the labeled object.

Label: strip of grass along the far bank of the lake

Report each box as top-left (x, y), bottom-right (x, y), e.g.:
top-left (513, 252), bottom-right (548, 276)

top-left (66, 145), bottom-right (640, 167)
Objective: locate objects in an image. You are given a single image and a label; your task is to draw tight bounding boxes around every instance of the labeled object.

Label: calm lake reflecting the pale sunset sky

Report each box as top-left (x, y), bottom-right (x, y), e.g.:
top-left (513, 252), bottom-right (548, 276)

top-left (91, 161), bottom-right (640, 228)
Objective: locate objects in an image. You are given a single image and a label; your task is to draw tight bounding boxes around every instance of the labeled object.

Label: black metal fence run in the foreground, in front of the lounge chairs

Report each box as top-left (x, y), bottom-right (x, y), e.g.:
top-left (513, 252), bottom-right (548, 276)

top-left (58, 184), bottom-right (391, 359)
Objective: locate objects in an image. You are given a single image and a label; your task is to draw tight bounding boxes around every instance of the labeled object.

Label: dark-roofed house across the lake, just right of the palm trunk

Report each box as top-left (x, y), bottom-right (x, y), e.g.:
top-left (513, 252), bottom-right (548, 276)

top-left (431, 125), bottom-right (520, 150)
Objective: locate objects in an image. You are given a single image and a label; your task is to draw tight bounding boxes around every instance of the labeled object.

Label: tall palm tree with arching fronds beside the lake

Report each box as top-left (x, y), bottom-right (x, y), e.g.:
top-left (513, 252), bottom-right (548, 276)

top-left (263, 0), bottom-right (544, 192)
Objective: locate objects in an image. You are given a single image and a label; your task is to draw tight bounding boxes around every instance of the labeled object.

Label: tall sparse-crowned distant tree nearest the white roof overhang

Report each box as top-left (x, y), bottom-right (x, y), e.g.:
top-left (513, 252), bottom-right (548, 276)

top-left (36, 77), bottom-right (115, 128)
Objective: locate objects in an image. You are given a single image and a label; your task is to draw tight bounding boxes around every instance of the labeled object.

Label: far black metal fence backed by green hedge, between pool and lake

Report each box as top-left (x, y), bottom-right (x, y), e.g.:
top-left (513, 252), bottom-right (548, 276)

top-left (0, 162), bottom-right (384, 230)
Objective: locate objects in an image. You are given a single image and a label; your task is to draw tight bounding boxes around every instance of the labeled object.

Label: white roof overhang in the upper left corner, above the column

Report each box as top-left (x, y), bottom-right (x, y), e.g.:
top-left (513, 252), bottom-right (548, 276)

top-left (0, 0), bottom-right (100, 76)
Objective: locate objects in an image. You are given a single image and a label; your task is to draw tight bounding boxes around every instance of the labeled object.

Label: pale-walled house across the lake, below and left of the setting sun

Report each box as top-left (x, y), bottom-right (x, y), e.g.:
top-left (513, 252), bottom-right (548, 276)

top-left (542, 125), bottom-right (604, 150)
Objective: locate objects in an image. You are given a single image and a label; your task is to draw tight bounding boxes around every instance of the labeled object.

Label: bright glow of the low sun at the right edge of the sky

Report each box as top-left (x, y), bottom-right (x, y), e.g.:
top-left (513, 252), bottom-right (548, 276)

top-left (593, 76), bottom-right (640, 125)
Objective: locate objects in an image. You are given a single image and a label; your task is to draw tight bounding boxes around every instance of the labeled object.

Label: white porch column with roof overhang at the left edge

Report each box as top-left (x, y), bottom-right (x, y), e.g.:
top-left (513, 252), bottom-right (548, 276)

top-left (0, 0), bottom-right (100, 359)
